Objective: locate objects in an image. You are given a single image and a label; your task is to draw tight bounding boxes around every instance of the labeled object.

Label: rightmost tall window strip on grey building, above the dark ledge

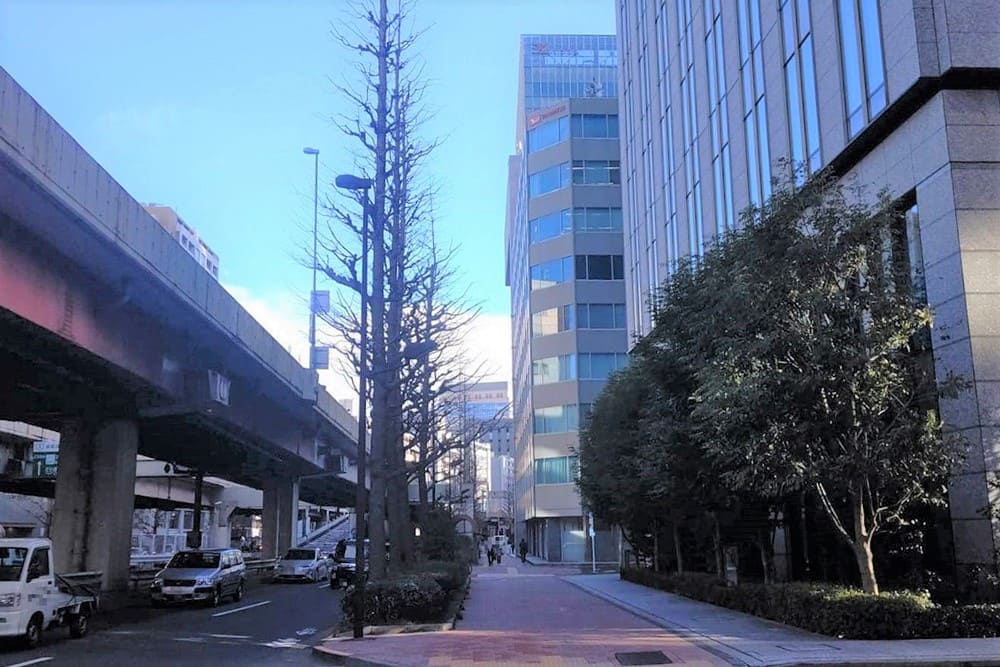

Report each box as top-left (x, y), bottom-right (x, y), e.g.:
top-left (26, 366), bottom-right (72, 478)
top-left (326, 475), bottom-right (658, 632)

top-left (837, 0), bottom-right (886, 137)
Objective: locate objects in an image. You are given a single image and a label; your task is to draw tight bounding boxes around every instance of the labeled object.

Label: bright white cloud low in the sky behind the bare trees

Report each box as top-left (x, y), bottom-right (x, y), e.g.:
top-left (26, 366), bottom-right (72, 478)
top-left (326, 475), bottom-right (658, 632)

top-left (224, 285), bottom-right (511, 410)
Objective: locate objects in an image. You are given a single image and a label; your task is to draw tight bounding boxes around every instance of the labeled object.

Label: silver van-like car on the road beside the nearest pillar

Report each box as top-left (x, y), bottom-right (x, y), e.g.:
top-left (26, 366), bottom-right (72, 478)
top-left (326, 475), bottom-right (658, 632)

top-left (149, 549), bottom-right (246, 607)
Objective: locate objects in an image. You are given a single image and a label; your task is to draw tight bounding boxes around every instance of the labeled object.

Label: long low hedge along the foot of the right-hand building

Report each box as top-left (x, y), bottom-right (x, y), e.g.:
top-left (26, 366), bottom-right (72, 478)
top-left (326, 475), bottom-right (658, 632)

top-left (622, 568), bottom-right (1000, 639)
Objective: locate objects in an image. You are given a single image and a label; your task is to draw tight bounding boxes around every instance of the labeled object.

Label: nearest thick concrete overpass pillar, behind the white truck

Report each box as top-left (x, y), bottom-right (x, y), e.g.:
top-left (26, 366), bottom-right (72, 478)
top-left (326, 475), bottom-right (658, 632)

top-left (52, 420), bottom-right (139, 591)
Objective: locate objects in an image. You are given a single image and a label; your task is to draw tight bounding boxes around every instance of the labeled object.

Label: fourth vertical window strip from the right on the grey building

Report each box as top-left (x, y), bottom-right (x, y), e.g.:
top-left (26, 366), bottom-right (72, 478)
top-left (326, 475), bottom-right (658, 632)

top-left (705, 0), bottom-right (736, 235)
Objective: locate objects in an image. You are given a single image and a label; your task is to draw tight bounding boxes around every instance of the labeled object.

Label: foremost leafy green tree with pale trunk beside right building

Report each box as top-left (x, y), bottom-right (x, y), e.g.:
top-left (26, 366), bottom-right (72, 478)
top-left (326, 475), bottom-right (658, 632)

top-left (686, 178), bottom-right (961, 592)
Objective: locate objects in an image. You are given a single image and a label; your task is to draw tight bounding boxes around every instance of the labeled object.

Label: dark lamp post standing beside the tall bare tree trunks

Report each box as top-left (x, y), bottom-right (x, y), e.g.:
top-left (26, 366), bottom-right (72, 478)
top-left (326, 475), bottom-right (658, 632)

top-left (335, 174), bottom-right (372, 639)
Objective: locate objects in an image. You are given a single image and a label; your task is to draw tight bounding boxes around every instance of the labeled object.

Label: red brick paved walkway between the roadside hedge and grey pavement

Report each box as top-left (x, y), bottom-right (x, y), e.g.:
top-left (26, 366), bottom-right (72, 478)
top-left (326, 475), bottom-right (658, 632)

top-left (319, 559), bottom-right (728, 667)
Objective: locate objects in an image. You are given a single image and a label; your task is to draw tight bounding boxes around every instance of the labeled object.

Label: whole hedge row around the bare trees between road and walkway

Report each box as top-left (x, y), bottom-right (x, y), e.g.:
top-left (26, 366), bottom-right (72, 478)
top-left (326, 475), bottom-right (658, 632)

top-left (340, 561), bottom-right (469, 625)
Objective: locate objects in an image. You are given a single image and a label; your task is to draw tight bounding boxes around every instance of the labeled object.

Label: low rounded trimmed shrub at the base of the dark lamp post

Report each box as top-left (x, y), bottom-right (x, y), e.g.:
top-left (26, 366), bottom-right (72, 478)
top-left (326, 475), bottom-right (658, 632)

top-left (340, 572), bottom-right (448, 625)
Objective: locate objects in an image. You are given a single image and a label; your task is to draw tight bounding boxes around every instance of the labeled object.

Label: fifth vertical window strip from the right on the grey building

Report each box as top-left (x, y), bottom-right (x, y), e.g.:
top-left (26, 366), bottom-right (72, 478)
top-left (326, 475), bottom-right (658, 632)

top-left (677, 0), bottom-right (705, 258)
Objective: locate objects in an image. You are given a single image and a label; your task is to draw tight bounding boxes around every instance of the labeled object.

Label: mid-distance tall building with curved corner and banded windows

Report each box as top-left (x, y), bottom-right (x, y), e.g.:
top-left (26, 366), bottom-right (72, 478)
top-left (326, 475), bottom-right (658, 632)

top-left (506, 35), bottom-right (628, 562)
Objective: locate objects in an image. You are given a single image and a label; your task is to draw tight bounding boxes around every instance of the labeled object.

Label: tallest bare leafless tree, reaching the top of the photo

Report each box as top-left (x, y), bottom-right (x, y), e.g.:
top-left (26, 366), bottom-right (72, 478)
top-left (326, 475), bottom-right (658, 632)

top-left (317, 0), bottom-right (446, 579)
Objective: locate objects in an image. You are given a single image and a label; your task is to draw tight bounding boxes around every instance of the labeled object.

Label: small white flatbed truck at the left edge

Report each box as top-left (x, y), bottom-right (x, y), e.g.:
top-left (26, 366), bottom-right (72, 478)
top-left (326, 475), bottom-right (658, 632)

top-left (0, 537), bottom-right (98, 648)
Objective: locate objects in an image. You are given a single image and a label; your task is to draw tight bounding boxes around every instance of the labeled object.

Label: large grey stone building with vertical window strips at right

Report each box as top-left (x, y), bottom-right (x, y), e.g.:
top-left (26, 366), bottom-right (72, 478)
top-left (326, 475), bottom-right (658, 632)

top-left (616, 0), bottom-right (1000, 584)
